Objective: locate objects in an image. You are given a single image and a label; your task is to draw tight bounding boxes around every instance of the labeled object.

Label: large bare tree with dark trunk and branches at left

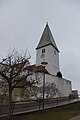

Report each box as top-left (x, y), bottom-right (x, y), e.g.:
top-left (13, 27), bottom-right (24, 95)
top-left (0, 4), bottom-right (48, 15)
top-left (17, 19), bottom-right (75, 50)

top-left (0, 50), bottom-right (35, 117)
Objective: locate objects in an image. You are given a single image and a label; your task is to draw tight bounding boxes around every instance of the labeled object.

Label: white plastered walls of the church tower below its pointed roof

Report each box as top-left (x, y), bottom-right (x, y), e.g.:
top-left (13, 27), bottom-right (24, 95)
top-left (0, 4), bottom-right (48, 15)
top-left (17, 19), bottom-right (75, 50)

top-left (36, 45), bottom-right (59, 75)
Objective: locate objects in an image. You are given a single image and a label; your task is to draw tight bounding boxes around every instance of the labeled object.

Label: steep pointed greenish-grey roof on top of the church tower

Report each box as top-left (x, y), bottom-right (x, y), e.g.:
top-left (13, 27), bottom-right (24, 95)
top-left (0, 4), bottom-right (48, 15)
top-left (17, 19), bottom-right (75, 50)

top-left (36, 23), bottom-right (59, 52)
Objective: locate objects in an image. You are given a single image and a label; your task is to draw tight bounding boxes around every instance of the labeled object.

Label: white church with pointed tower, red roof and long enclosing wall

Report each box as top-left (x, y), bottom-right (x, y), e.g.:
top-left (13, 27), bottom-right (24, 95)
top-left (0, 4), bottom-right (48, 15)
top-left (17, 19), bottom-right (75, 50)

top-left (1, 23), bottom-right (78, 101)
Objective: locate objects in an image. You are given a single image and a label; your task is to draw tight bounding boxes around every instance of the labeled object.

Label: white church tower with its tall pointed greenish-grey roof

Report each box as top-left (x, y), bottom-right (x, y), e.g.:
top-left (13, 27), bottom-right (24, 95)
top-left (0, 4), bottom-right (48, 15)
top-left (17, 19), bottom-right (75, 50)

top-left (36, 23), bottom-right (60, 75)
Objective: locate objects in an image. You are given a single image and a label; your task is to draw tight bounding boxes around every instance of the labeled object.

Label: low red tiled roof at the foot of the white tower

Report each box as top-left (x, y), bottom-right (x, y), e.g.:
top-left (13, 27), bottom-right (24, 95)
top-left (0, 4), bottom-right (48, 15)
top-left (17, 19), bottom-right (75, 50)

top-left (25, 65), bottom-right (49, 74)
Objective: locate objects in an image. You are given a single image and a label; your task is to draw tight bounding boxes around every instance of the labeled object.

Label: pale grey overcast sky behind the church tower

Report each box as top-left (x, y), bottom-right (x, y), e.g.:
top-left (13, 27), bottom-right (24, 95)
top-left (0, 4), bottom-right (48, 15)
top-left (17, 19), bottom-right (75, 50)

top-left (0, 0), bottom-right (80, 91)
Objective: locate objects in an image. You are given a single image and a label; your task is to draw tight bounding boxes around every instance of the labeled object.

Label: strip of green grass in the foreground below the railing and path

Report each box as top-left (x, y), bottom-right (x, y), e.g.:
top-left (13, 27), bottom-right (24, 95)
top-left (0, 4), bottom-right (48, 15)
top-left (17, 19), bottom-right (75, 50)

top-left (0, 108), bottom-right (80, 120)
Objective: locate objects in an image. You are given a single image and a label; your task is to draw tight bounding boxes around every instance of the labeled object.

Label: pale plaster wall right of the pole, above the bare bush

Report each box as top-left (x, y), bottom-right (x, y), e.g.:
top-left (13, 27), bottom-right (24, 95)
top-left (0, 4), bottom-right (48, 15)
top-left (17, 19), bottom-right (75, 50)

top-left (45, 75), bottom-right (72, 97)
